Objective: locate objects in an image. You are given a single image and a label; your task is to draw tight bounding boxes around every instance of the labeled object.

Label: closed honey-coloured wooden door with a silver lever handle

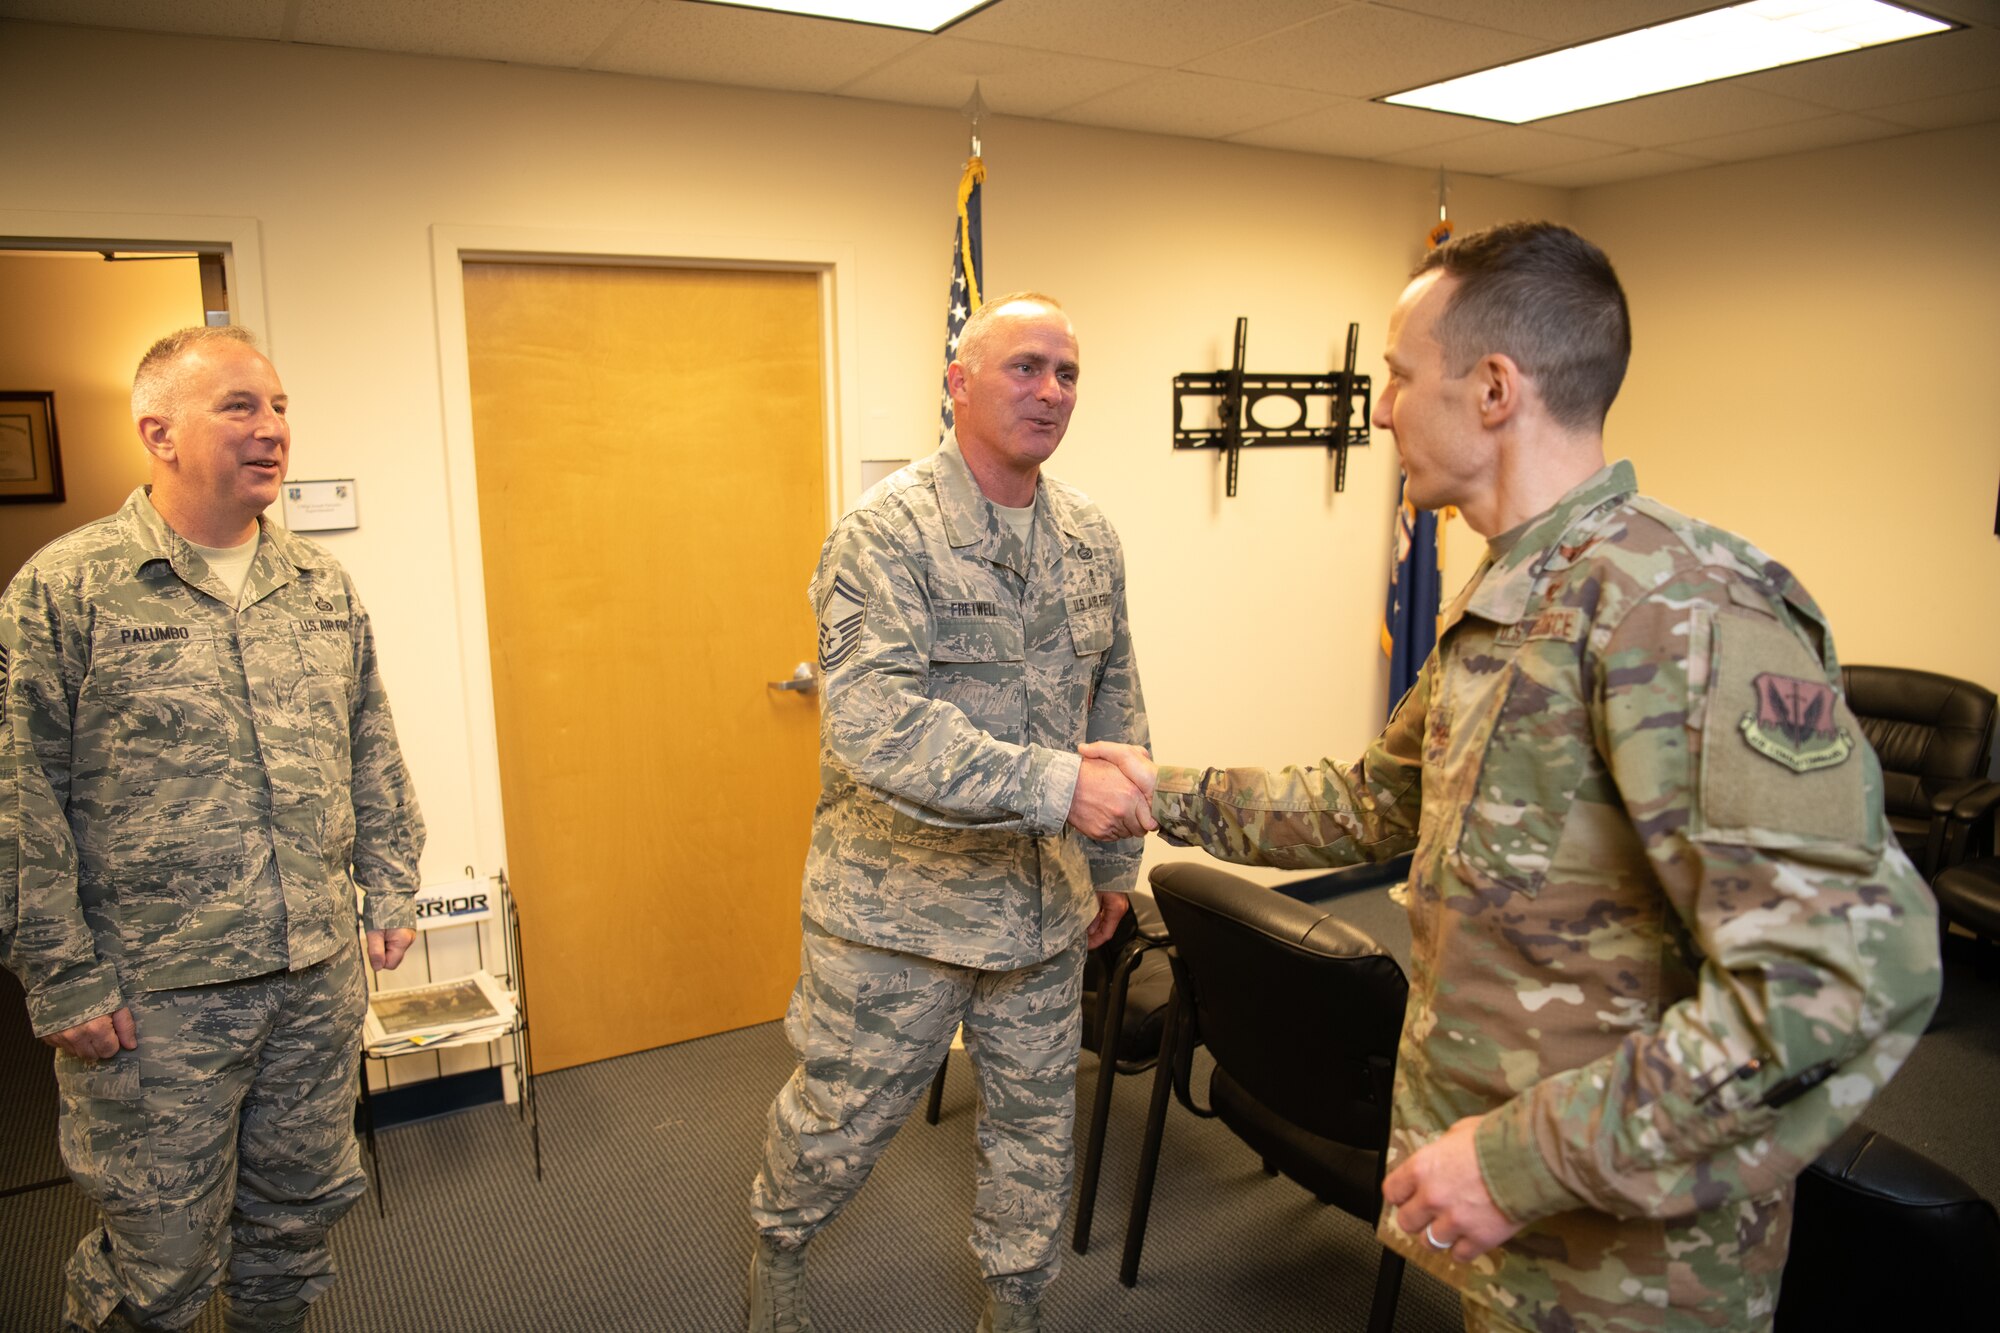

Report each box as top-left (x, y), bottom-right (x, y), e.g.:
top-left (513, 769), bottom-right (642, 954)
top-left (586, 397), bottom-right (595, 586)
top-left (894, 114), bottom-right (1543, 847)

top-left (464, 262), bottom-right (826, 1069)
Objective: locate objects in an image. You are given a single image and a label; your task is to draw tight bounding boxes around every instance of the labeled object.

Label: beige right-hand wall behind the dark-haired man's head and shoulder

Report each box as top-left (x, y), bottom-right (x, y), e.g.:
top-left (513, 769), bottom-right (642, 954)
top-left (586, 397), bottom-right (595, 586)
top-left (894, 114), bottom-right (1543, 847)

top-left (1576, 124), bottom-right (2000, 689)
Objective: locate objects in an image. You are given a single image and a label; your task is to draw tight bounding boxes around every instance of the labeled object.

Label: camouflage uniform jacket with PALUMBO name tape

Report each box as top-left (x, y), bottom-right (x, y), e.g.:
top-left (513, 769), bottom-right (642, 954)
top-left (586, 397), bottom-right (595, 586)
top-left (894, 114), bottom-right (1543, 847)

top-left (0, 486), bottom-right (424, 1033)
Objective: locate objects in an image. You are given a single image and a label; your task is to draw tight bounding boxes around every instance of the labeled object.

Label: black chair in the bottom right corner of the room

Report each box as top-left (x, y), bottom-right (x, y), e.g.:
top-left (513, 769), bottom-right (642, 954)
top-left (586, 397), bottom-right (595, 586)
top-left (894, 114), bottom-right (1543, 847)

top-left (1774, 1125), bottom-right (2000, 1333)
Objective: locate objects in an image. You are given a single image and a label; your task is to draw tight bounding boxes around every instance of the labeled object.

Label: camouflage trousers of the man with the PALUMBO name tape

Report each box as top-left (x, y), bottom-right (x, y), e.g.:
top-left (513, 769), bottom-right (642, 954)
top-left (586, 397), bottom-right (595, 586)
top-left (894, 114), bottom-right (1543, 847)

top-left (56, 947), bottom-right (368, 1329)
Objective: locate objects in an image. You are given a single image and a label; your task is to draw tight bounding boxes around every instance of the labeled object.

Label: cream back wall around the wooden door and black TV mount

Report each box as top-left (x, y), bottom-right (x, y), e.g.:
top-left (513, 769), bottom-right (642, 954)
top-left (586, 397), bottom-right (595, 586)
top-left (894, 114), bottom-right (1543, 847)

top-left (0, 24), bottom-right (1568, 881)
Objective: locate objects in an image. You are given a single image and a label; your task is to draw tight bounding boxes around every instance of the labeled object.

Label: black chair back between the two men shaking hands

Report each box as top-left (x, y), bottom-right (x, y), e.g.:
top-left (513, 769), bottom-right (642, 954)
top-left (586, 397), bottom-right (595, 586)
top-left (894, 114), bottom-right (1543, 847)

top-left (1152, 863), bottom-right (1410, 1151)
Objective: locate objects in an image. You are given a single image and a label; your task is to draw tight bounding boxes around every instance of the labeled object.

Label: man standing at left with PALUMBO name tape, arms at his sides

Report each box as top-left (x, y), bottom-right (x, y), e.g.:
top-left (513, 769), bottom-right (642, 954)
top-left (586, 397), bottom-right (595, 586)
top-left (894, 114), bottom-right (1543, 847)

top-left (0, 328), bottom-right (424, 1331)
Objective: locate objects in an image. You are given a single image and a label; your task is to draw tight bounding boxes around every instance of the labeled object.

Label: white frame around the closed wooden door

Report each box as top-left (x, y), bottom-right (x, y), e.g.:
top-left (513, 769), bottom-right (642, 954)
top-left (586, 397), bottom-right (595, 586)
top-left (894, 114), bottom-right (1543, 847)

top-left (430, 222), bottom-right (860, 873)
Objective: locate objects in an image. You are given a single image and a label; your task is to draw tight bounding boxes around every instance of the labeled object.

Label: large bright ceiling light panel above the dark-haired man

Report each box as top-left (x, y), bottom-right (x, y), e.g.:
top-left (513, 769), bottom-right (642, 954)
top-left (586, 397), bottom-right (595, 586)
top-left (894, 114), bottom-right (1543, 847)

top-left (1380, 0), bottom-right (1954, 124)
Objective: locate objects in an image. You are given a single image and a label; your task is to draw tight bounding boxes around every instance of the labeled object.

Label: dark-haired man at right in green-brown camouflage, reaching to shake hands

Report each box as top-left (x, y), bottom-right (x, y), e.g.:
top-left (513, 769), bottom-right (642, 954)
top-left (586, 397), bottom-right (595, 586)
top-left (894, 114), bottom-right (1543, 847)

top-left (1086, 224), bottom-right (1940, 1333)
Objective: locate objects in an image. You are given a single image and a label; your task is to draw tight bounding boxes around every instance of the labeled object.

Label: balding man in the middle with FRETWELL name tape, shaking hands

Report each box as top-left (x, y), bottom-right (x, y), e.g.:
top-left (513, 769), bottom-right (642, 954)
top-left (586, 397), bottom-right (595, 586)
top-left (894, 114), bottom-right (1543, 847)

top-left (750, 294), bottom-right (1146, 1333)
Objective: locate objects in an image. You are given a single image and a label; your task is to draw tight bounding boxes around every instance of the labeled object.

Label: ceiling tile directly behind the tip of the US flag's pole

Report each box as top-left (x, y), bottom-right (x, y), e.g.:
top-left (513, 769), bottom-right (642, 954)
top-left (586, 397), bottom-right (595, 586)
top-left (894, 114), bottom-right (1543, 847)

top-left (840, 36), bottom-right (1154, 116)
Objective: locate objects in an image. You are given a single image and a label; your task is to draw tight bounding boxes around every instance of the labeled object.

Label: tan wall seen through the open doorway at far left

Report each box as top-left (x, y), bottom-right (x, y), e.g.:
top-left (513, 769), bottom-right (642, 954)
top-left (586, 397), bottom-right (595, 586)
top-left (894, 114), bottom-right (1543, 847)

top-left (0, 252), bottom-right (202, 586)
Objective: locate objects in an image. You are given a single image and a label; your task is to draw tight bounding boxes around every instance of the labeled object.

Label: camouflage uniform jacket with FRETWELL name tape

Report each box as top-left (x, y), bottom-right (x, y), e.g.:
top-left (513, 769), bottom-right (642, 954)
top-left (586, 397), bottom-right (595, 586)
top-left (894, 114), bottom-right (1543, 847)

top-left (802, 436), bottom-right (1146, 969)
